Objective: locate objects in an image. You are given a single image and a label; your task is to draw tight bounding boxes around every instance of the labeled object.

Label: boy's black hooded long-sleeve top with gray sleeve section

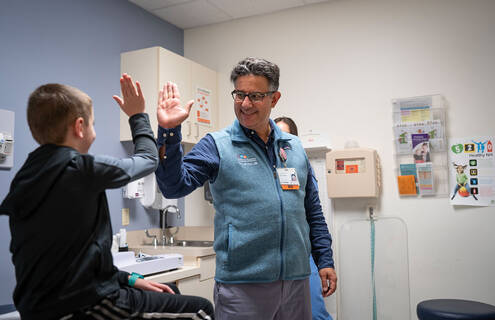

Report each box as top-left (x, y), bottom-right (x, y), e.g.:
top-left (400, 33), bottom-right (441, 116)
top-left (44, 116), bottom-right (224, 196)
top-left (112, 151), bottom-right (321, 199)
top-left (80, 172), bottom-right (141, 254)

top-left (0, 114), bottom-right (158, 320)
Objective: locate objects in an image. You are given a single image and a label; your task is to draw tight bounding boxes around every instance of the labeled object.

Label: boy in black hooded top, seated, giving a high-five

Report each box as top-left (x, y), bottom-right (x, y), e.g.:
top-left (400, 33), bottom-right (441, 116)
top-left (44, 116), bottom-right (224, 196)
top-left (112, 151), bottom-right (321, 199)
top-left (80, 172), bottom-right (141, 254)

top-left (0, 74), bottom-right (213, 320)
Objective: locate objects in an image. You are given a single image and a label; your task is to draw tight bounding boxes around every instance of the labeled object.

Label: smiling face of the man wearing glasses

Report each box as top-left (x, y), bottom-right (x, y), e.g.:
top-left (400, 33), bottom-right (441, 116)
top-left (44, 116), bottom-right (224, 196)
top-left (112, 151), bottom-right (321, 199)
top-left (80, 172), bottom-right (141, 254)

top-left (234, 74), bottom-right (280, 135)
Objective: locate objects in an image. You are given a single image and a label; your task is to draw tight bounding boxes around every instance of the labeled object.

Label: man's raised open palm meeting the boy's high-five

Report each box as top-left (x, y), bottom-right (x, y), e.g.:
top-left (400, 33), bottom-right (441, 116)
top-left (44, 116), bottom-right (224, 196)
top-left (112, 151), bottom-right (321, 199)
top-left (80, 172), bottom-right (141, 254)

top-left (156, 82), bottom-right (194, 129)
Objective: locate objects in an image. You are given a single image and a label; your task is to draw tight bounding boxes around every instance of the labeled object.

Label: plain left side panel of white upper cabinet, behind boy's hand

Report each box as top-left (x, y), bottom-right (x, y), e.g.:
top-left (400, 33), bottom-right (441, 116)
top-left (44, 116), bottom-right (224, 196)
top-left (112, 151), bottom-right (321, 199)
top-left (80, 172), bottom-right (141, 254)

top-left (120, 47), bottom-right (159, 141)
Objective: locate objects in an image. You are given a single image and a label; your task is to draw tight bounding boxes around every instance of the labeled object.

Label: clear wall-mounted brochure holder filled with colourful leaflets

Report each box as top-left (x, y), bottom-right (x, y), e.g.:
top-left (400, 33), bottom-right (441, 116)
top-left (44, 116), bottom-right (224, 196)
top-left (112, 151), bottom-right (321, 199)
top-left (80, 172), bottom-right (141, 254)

top-left (392, 95), bottom-right (448, 196)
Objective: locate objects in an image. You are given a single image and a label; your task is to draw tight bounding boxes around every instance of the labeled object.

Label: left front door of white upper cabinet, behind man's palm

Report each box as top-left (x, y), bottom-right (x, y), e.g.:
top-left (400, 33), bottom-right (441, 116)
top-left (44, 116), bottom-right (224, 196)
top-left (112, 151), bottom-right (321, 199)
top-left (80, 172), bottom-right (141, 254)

top-left (159, 48), bottom-right (197, 143)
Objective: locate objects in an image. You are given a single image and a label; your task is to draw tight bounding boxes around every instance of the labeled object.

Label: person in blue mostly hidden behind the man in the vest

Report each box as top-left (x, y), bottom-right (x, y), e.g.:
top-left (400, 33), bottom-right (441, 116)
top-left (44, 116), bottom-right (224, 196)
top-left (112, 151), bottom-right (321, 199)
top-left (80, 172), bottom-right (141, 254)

top-left (273, 117), bottom-right (332, 320)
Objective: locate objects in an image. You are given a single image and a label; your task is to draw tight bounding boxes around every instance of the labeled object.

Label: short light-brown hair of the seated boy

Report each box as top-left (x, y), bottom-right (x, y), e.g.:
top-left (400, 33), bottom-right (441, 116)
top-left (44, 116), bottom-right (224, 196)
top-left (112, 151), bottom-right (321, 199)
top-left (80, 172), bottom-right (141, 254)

top-left (27, 83), bottom-right (93, 145)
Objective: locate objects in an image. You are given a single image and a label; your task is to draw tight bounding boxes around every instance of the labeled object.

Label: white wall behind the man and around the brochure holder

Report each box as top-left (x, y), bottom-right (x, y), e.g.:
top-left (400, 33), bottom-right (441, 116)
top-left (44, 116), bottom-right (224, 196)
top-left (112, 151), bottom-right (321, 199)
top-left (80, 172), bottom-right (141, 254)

top-left (184, 0), bottom-right (495, 318)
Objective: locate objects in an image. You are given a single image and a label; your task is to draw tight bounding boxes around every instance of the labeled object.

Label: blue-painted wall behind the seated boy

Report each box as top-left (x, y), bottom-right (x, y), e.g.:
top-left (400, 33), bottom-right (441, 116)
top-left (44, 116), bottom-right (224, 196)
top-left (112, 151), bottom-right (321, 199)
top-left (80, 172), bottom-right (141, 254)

top-left (0, 0), bottom-right (184, 305)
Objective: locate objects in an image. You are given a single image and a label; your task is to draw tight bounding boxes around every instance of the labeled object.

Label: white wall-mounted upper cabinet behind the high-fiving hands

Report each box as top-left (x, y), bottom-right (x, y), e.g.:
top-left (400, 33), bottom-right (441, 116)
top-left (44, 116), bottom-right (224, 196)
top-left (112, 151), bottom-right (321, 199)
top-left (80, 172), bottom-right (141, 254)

top-left (120, 47), bottom-right (218, 144)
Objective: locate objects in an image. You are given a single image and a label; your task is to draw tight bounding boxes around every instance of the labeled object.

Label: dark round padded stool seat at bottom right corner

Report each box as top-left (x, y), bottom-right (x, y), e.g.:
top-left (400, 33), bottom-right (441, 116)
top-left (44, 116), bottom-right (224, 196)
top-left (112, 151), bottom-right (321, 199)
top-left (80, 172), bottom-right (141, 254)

top-left (416, 299), bottom-right (495, 320)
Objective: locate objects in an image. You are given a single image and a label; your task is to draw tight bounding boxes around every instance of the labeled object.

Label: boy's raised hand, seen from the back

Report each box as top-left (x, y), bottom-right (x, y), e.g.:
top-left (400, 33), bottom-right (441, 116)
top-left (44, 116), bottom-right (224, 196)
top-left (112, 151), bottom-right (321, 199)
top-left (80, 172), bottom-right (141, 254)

top-left (113, 73), bottom-right (145, 117)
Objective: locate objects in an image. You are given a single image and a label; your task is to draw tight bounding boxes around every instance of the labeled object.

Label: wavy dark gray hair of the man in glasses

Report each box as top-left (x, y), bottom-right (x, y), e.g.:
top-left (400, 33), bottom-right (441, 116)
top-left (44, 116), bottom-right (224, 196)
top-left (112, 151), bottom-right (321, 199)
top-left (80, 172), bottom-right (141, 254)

top-left (230, 57), bottom-right (280, 91)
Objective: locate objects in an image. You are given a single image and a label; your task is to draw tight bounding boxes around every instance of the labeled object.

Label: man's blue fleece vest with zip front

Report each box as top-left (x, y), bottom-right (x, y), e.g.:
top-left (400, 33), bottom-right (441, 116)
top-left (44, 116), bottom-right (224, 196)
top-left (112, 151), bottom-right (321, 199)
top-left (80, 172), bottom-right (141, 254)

top-left (211, 120), bottom-right (311, 283)
